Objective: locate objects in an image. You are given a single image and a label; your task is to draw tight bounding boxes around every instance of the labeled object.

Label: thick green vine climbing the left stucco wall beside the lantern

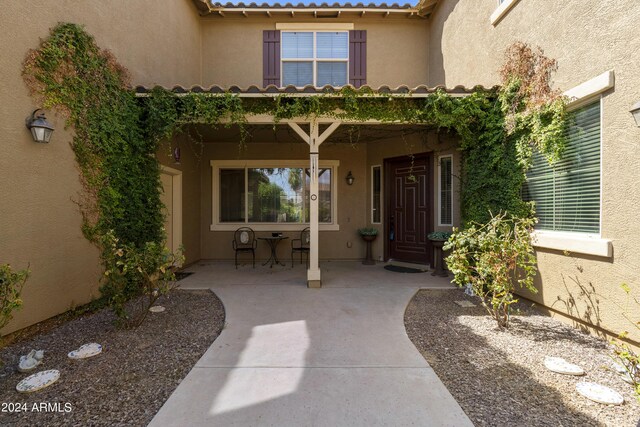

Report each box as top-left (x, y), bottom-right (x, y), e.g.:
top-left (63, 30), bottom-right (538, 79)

top-left (23, 24), bottom-right (163, 251)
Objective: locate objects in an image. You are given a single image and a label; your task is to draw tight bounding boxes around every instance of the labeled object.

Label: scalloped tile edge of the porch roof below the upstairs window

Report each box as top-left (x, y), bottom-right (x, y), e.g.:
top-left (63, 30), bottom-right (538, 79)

top-left (135, 85), bottom-right (498, 98)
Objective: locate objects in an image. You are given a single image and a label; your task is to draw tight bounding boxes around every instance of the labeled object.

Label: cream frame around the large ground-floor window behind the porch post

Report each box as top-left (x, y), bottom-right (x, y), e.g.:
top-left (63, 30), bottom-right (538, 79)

top-left (209, 160), bottom-right (340, 231)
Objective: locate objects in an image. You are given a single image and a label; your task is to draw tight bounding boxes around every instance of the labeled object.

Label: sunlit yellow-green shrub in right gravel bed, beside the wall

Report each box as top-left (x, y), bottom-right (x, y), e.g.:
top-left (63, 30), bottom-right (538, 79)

top-left (444, 213), bottom-right (537, 328)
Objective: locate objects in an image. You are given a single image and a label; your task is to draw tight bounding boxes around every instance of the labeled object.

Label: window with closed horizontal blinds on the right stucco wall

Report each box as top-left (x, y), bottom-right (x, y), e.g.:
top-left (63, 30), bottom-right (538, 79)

top-left (523, 101), bottom-right (600, 233)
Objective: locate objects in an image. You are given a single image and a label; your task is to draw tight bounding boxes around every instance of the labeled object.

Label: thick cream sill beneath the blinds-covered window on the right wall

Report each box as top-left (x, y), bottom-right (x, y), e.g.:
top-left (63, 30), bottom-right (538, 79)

top-left (532, 231), bottom-right (613, 258)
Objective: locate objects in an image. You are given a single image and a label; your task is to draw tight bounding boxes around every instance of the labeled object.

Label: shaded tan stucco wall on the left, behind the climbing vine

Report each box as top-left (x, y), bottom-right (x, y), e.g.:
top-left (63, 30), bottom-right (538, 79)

top-left (0, 0), bottom-right (200, 333)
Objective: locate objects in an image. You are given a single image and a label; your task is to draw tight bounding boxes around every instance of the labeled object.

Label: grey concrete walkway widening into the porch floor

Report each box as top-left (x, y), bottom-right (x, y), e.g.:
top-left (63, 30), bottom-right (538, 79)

top-left (150, 263), bottom-right (472, 427)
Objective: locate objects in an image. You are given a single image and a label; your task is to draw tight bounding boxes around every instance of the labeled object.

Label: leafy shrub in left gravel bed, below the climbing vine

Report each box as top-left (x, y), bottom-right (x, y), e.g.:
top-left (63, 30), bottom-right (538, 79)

top-left (100, 231), bottom-right (184, 328)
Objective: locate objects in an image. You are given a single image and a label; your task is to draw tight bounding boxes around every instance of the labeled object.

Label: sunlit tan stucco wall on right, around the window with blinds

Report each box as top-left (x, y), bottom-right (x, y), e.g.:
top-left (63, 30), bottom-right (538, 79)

top-left (429, 0), bottom-right (640, 341)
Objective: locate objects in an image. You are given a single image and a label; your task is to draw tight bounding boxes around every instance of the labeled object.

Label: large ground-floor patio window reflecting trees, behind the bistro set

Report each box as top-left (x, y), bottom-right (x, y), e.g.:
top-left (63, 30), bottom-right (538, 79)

top-left (212, 161), bottom-right (337, 230)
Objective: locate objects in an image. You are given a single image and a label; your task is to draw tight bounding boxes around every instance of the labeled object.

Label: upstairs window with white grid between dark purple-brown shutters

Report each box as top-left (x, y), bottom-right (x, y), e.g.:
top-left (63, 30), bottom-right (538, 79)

top-left (281, 31), bottom-right (349, 87)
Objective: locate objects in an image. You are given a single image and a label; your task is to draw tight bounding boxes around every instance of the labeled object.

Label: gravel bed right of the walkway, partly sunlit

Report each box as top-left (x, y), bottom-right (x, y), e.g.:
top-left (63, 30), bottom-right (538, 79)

top-left (405, 289), bottom-right (640, 427)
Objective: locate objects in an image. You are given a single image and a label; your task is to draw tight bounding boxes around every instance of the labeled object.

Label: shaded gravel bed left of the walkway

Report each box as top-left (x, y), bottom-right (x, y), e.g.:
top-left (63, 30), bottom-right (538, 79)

top-left (0, 290), bottom-right (224, 426)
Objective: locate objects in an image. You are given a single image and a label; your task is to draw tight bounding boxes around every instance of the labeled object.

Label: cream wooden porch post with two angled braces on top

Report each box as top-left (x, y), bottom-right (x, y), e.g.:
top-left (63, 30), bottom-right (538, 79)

top-left (289, 120), bottom-right (340, 288)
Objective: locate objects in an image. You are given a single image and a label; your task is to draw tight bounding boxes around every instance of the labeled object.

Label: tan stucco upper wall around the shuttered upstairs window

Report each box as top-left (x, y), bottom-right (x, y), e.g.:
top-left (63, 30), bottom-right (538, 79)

top-left (202, 16), bottom-right (429, 87)
